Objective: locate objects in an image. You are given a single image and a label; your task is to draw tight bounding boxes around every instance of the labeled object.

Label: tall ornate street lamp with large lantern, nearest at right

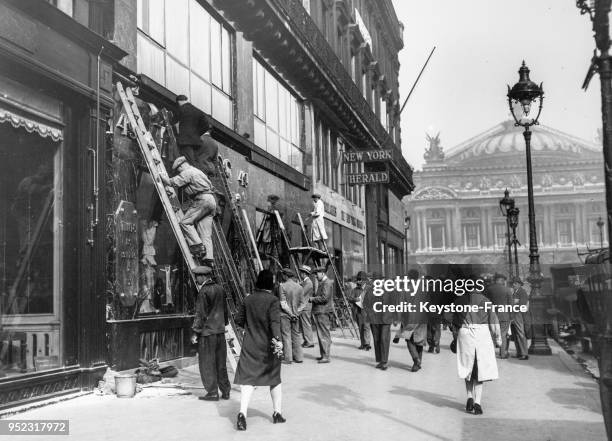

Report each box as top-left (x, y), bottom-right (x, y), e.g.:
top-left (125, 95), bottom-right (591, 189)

top-left (507, 61), bottom-right (552, 355)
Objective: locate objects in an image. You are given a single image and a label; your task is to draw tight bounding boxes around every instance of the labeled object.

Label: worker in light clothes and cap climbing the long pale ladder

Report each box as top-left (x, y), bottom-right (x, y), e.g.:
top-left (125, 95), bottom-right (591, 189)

top-left (160, 156), bottom-right (217, 266)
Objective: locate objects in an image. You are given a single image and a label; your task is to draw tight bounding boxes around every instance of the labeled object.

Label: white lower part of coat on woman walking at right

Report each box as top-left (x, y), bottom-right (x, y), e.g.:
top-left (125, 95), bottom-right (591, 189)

top-left (457, 324), bottom-right (499, 381)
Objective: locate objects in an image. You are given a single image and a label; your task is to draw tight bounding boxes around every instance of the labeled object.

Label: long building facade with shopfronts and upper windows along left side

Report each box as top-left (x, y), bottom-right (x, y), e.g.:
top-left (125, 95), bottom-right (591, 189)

top-left (0, 0), bottom-right (413, 407)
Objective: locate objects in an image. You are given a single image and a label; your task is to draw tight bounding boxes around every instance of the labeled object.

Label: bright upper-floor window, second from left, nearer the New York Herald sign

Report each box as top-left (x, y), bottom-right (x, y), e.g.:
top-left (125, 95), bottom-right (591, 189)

top-left (253, 58), bottom-right (304, 172)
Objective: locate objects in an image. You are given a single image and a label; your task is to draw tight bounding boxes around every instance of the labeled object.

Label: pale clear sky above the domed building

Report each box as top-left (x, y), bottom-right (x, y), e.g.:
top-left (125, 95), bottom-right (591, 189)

top-left (393, 0), bottom-right (601, 169)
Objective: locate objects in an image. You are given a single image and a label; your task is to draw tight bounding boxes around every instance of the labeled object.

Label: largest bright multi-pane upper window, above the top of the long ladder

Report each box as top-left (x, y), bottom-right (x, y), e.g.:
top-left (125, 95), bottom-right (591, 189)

top-left (137, 0), bottom-right (234, 128)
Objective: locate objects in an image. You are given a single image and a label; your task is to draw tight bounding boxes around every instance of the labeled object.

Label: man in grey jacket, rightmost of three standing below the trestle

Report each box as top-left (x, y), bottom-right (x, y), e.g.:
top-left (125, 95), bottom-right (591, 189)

top-left (310, 266), bottom-right (334, 363)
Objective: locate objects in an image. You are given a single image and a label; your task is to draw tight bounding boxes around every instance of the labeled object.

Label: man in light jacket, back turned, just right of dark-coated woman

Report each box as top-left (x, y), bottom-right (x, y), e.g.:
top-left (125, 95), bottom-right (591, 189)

top-left (279, 268), bottom-right (306, 364)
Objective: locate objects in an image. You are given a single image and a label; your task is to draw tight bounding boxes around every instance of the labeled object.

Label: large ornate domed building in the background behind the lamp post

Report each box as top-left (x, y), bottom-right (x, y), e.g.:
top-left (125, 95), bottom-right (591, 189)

top-left (406, 121), bottom-right (607, 277)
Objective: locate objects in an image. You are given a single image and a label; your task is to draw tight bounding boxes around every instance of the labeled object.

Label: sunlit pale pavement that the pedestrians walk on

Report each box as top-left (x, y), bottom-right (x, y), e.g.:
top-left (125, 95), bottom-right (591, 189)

top-left (4, 332), bottom-right (605, 441)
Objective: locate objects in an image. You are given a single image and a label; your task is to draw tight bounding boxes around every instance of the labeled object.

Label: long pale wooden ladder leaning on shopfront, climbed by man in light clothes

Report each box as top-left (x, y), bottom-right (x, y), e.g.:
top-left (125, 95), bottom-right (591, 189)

top-left (117, 82), bottom-right (240, 371)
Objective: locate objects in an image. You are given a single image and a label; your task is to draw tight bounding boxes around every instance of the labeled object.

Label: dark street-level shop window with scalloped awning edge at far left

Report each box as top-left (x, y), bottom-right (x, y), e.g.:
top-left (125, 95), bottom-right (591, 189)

top-left (0, 123), bottom-right (63, 376)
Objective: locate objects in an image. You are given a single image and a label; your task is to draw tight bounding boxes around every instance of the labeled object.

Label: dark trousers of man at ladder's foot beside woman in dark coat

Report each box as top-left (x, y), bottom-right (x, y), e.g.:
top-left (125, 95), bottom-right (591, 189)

top-left (198, 334), bottom-right (232, 394)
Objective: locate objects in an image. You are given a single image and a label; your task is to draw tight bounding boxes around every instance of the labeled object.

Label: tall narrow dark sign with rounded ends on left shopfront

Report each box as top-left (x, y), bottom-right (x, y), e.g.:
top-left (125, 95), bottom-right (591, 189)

top-left (115, 201), bottom-right (138, 306)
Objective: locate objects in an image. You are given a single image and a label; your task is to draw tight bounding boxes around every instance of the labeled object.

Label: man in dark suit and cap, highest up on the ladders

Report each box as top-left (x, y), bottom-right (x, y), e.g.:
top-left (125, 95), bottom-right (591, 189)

top-left (172, 95), bottom-right (210, 169)
